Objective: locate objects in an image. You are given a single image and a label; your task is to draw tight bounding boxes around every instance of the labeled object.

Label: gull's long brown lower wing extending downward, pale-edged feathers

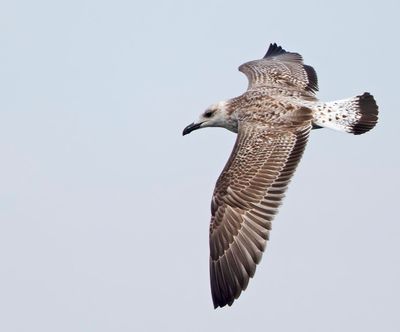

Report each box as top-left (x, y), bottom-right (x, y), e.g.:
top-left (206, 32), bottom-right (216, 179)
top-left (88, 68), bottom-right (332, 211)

top-left (210, 121), bottom-right (311, 308)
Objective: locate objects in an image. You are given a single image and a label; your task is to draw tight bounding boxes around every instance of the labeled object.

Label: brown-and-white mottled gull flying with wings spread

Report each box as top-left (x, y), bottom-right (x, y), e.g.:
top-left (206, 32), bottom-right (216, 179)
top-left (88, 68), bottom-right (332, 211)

top-left (183, 44), bottom-right (378, 308)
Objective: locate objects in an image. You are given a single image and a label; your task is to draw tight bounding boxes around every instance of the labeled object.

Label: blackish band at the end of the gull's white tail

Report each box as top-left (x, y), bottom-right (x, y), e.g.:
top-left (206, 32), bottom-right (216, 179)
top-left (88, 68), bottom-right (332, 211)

top-left (351, 92), bottom-right (378, 135)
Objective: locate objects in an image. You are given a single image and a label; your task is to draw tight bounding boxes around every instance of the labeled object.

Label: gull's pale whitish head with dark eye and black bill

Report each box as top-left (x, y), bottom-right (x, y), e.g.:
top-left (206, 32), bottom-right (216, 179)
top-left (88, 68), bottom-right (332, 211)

top-left (183, 101), bottom-right (237, 135)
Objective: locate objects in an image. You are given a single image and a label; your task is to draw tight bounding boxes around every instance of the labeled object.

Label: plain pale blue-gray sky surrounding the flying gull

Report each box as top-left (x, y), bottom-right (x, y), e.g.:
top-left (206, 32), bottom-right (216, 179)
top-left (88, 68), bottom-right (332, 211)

top-left (0, 0), bottom-right (400, 332)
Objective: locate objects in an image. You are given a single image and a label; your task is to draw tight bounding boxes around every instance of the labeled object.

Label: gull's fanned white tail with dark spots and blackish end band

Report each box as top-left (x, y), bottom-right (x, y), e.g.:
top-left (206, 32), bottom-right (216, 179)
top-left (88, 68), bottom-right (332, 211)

top-left (314, 92), bottom-right (378, 135)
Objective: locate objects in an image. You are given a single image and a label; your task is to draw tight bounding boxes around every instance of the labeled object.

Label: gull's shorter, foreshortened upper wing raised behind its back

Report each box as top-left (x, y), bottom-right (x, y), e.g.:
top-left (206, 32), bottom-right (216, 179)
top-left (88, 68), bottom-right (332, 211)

top-left (239, 44), bottom-right (318, 94)
